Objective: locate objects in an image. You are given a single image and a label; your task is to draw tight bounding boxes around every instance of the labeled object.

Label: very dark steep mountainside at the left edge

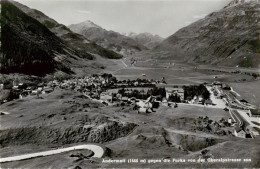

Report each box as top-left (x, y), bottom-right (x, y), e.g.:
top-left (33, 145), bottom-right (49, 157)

top-left (0, 0), bottom-right (83, 76)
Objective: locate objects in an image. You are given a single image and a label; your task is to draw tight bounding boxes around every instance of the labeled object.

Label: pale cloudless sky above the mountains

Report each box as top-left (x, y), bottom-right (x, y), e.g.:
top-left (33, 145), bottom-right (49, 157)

top-left (17, 0), bottom-right (231, 38)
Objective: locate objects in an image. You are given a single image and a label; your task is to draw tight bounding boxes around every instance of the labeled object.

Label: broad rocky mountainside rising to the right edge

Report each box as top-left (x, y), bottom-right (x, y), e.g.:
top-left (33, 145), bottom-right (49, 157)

top-left (153, 1), bottom-right (260, 67)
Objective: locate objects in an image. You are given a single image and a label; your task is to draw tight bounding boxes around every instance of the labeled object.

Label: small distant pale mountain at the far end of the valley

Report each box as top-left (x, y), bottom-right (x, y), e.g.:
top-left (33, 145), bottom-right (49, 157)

top-left (128, 33), bottom-right (163, 49)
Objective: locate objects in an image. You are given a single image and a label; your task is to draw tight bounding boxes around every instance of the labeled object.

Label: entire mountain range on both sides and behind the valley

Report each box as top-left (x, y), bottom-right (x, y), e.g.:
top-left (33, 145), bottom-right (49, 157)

top-left (0, 0), bottom-right (260, 76)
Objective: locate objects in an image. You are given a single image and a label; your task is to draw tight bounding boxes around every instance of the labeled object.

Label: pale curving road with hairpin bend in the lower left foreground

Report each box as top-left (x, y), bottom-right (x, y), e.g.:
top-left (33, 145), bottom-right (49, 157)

top-left (0, 144), bottom-right (104, 163)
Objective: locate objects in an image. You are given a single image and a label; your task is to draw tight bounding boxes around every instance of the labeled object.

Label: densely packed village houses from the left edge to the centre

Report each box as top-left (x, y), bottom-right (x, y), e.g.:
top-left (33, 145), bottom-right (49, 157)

top-left (0, 74), bottom-right (219, 112)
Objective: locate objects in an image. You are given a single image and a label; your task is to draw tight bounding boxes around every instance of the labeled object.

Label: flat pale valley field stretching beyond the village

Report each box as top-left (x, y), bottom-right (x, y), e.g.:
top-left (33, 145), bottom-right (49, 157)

top-left (112, 60), bottom-right (252, 84)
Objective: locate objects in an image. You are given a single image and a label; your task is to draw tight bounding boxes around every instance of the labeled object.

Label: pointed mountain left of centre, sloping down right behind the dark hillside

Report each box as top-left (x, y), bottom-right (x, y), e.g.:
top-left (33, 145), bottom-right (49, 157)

top-left (69, 21), bottom-right (147, 56)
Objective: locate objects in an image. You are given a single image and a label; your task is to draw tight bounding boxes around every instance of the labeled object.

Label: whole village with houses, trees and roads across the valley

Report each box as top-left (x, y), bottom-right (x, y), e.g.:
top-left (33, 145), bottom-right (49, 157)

top-left (0, 74), bottom-right (260, 138)
